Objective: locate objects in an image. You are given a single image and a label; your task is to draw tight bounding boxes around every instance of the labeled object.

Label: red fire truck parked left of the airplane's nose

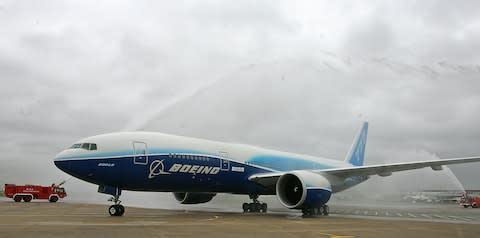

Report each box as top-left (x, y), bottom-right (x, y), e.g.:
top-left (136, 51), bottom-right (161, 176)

top-left (3, 184), bottom-right (67, 202)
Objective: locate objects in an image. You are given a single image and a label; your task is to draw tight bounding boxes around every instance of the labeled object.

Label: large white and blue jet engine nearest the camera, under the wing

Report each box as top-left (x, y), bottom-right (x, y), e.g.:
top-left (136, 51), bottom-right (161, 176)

top-left (276, 171), bottom-right (332, 209)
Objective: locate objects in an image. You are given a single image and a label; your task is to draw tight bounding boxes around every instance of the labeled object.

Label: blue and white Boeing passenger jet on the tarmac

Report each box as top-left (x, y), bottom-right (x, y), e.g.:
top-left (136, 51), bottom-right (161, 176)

top-left (54, 122), bottom-right (480, 216)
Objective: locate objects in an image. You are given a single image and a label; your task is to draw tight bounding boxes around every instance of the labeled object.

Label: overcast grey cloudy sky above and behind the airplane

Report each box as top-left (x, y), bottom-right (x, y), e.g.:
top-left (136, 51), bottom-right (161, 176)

top-left (0, 0), bottom-right (480, 205)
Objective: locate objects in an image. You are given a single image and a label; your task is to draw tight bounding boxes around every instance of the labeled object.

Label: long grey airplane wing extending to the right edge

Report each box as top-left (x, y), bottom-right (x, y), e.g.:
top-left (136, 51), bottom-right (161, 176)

top-left (249, 157), bottom-right (480, 187)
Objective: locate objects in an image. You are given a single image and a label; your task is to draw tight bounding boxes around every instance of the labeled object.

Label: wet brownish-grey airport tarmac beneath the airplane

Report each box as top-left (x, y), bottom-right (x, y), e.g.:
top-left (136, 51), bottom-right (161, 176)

top-left (0, 200), bottom-right (480, 238)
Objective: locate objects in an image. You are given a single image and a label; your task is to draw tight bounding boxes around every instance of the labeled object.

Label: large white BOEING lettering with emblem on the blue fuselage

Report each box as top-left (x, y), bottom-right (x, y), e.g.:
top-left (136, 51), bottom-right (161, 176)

top-left (148, 160), bottom-right (220, 179)
